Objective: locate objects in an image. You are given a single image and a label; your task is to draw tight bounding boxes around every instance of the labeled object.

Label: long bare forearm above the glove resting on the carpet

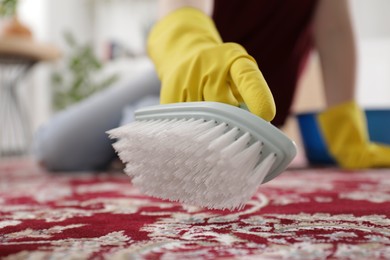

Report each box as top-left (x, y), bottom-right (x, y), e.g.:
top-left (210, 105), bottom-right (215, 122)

top-left (313, 0), bottom-right (357, 106)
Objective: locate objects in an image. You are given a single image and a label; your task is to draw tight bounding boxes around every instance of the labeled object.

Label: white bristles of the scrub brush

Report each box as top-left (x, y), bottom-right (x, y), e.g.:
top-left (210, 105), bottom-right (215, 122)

top-left (108, 118), bottom-right (276, 210)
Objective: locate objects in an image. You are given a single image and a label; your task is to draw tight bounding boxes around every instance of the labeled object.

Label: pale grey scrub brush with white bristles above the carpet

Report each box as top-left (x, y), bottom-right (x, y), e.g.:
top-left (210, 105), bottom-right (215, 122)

top-left (108, 102), bottom-right (296, 210)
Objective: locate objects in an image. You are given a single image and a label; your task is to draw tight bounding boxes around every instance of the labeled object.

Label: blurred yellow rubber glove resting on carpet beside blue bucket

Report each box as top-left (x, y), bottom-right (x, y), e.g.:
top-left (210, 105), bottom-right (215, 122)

top-left (317, 101), bottom-right (390, 169)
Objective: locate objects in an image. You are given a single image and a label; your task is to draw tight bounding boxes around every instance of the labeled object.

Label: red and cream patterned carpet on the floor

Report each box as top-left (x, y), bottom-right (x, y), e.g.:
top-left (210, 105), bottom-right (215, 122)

top-left (0, 161), bottom-right (390, 259)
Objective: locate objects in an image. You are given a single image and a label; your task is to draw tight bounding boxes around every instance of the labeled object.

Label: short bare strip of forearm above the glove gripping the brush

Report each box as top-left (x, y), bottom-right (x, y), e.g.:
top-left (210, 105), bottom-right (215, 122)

top-left (158, 0), bottom-right (214, 18)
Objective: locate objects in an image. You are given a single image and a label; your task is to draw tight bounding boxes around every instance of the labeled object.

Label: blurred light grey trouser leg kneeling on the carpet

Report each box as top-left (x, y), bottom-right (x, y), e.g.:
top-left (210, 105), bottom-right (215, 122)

top-left (33, 68), bottom-right (160, 171)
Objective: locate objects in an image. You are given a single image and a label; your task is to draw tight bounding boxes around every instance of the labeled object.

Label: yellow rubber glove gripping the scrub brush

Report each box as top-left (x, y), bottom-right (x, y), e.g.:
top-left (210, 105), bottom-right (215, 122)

top-left (148, 8), bottom-right (275, 121)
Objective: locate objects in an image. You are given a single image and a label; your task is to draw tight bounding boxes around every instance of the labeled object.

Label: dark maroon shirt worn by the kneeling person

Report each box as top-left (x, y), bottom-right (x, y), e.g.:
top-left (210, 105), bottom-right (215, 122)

top-left (213, 0), bottom-right (317, 126)
